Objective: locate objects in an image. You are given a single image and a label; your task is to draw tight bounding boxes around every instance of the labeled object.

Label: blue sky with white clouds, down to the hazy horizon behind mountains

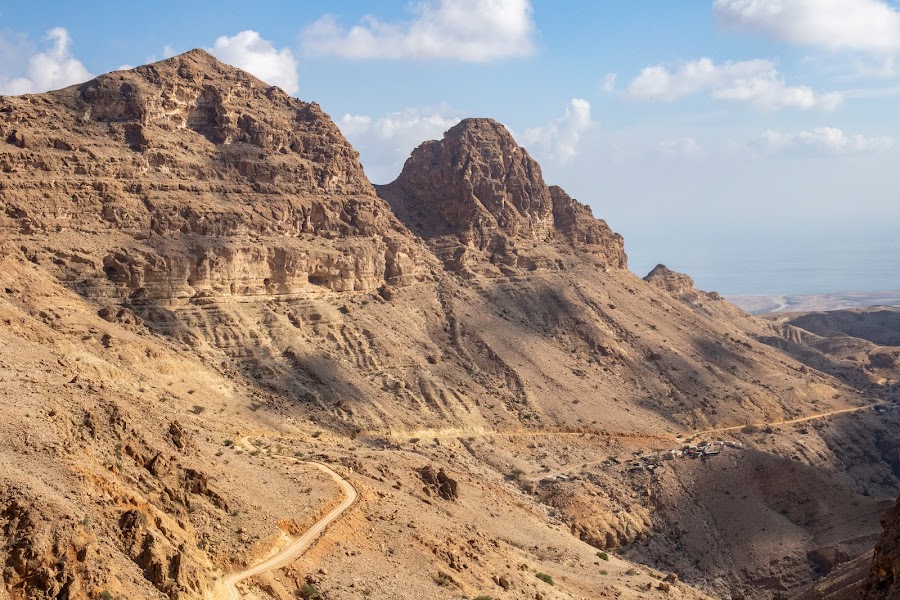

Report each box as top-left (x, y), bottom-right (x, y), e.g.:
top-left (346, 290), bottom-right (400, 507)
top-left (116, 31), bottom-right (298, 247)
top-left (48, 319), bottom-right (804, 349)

top-left (0, 0), bottom-right (900, 293)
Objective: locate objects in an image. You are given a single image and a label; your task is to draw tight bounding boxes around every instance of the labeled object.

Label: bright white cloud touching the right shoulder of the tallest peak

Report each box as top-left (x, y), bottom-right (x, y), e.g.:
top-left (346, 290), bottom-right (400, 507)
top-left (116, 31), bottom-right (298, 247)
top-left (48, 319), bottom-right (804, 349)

top-left (209, 30), bottom-right (300, 96)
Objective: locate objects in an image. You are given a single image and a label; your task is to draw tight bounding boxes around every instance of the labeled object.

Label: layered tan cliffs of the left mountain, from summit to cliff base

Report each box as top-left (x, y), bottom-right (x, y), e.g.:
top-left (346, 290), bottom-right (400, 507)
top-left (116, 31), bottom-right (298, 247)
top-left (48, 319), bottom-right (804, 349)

top-left (0, 50), bottom-right (421, 300)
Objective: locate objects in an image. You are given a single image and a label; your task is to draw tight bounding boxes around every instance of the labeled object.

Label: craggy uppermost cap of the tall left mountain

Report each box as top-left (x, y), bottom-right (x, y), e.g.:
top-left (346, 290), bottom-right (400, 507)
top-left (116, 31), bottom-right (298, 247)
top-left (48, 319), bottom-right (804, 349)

top-left (63, 49), bottom-right (373, 195)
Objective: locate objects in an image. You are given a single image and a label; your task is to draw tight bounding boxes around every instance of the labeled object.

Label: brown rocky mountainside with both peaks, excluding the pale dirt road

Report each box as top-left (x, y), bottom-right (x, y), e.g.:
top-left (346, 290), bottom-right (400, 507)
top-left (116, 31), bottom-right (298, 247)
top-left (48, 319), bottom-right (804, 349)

top-left (0, 51), bottom-right (900, 598)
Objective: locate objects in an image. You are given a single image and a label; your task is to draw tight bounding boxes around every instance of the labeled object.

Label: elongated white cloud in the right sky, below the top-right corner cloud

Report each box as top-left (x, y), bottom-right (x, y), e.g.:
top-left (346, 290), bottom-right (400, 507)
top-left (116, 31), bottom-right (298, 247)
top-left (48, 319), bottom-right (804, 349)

top-left (628, 58), bottom-right (841, 111)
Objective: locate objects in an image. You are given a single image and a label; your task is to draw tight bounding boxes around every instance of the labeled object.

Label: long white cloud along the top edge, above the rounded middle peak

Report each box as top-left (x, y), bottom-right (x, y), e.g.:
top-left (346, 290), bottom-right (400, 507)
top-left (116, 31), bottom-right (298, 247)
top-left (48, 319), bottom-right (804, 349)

top-left (303, 0), bottom-right (535, 62)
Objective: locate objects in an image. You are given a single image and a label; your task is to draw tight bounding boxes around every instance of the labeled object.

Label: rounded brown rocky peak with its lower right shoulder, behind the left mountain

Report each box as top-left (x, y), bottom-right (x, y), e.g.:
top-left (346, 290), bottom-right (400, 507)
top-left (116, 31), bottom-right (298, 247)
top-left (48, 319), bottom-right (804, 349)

top-left (378, 119), bottom-right (625, 272)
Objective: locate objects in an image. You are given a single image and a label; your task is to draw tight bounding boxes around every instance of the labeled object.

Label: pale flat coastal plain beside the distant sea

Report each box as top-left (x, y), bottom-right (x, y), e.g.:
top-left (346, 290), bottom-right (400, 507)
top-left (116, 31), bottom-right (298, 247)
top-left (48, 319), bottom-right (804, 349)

top-left (726, 290), bottom-right (900, 315)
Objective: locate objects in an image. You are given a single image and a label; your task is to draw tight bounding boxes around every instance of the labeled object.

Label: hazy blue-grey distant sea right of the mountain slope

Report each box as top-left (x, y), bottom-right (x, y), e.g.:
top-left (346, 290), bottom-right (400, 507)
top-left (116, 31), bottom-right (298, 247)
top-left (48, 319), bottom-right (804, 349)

top-left (625, 227), bottom-right (900, 296)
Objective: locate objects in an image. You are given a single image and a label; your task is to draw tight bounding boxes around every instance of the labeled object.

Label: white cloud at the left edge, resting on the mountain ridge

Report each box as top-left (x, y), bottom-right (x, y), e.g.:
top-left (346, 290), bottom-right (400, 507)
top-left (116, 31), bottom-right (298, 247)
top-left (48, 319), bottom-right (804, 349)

top-left (0, 27), bottom-right (93, 95)
